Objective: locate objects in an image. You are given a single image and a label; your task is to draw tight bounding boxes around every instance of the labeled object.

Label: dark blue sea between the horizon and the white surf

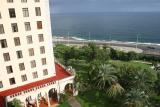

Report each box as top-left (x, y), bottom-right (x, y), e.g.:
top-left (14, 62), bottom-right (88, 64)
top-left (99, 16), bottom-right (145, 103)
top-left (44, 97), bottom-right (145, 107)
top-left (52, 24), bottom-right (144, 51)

top-left (51, 12), bottom-right (160, 43)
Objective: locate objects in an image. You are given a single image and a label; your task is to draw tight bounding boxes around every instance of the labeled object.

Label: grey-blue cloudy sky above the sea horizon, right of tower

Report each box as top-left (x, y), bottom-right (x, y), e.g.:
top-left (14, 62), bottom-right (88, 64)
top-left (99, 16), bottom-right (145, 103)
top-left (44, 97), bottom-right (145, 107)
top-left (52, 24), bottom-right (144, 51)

top-left (50, 0), bottom-right (160, 13)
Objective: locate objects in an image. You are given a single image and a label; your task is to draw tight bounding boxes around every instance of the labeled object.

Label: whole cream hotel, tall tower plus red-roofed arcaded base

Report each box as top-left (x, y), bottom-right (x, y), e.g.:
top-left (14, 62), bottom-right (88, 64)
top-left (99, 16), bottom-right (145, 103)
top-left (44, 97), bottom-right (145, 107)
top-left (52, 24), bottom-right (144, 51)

top-left (0, 0), bottom-right (74, 107)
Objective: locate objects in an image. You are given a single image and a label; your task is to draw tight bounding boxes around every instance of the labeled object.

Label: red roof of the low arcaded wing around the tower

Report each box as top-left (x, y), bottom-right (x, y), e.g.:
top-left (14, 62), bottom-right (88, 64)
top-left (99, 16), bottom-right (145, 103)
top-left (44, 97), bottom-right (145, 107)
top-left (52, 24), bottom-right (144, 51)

top-left (0, 63), bottom-right (71, 98)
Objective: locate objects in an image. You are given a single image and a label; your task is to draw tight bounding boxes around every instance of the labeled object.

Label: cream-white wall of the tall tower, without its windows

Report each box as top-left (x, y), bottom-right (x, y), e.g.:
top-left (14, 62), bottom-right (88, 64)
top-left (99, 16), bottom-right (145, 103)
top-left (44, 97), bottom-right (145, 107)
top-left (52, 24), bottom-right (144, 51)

top-left (0, 0), bottom-right (55, 91)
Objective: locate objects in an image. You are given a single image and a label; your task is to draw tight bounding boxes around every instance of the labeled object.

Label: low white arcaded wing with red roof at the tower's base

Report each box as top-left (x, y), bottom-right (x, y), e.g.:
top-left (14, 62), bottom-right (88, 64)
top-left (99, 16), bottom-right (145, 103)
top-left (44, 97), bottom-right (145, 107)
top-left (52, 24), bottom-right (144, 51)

top-left (0, 63), bottom-right (74, 107)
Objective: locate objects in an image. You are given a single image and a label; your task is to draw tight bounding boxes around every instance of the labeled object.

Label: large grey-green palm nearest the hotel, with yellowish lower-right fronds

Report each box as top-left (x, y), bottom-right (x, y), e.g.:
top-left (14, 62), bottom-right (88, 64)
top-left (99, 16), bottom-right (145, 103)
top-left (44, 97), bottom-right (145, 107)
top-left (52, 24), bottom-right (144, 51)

top-left (95, 64), bottom-right (124, 97)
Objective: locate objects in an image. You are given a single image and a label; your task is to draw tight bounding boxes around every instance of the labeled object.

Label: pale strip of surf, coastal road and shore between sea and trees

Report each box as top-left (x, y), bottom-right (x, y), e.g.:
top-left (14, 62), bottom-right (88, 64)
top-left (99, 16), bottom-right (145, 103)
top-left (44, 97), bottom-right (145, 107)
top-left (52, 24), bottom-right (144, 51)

top-left (53, 36), bottom-right (160, 56)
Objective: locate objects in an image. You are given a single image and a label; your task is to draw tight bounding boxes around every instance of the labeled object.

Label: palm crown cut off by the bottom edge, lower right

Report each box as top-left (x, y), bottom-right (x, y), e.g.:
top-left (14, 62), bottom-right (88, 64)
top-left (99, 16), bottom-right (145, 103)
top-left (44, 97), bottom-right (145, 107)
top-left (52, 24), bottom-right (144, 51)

top-left (124, 89), bottom-right (149, 107)
